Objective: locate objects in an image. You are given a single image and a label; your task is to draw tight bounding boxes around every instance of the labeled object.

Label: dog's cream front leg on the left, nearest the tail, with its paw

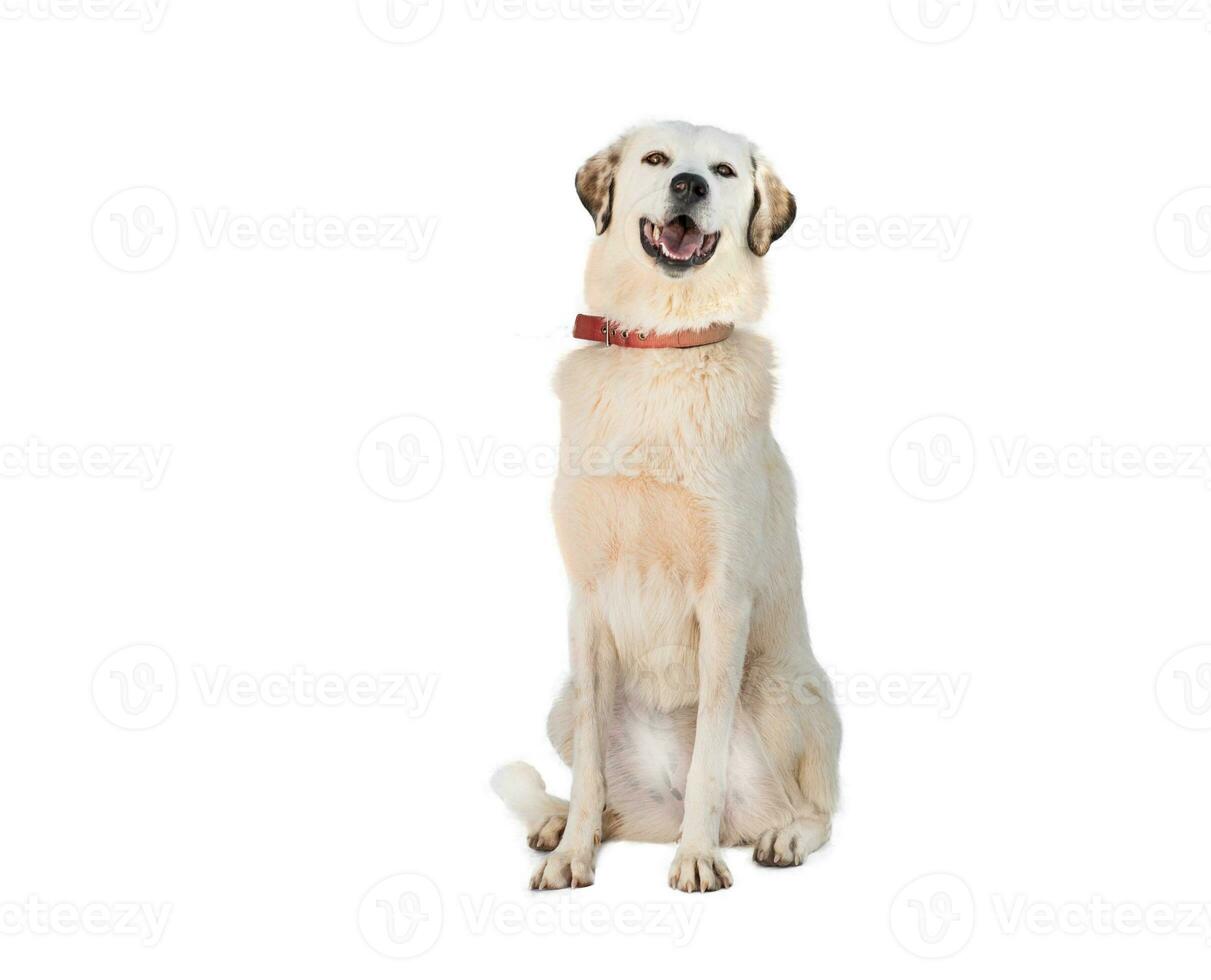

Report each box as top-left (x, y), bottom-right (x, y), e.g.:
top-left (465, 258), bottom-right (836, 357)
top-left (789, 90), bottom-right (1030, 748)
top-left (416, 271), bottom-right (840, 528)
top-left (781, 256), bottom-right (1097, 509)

top-left (530, 596), bottom-right (615, 888)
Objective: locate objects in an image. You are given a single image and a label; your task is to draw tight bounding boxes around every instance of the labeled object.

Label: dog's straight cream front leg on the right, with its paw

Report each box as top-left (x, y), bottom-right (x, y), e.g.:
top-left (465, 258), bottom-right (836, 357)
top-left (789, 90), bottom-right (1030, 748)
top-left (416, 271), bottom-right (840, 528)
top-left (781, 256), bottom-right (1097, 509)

top-left (668, 597), bottom-right (750, 892)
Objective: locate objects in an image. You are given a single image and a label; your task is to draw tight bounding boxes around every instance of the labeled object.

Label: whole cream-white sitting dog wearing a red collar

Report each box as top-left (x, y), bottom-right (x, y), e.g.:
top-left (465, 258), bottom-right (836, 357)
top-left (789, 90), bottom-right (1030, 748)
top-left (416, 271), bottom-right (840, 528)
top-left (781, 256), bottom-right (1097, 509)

top-left (493, 122), bottom-right (840, 892)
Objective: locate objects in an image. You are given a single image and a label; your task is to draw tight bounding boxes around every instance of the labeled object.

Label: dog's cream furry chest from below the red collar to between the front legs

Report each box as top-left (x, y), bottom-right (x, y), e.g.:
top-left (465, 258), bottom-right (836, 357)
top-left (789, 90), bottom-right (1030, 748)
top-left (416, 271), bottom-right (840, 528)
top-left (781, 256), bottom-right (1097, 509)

top-left (553, 339), bottom-right (770, 707)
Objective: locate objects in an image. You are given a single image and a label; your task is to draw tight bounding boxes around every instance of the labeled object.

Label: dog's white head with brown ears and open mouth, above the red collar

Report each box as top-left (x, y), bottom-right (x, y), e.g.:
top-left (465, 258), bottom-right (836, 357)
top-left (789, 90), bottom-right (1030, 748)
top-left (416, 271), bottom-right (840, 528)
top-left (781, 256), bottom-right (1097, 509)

top-left (576, 122), bottom-right (794, 329)
